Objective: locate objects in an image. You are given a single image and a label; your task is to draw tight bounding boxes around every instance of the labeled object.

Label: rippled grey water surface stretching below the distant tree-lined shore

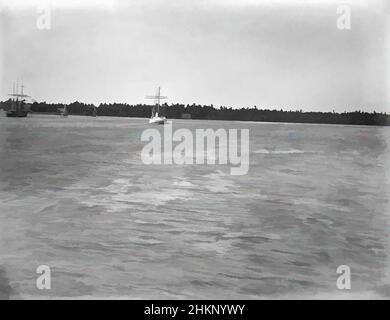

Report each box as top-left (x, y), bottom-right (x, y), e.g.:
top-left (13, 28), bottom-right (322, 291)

top-left (0, 115), bottom-right (390, 299)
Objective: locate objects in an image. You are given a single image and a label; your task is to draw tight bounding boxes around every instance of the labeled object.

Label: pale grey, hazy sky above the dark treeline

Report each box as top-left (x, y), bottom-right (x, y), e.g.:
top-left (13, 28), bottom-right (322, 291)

top-left (0, 0), bottom-right (390, 112)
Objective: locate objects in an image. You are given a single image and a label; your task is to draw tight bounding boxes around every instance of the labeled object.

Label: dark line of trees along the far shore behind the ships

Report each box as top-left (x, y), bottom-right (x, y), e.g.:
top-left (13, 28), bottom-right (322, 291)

top-left (0, 101), bottom-right (390, 126)
